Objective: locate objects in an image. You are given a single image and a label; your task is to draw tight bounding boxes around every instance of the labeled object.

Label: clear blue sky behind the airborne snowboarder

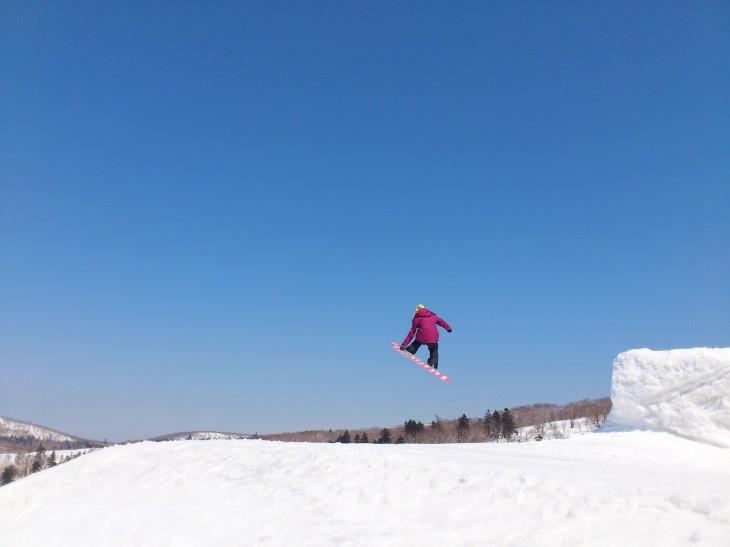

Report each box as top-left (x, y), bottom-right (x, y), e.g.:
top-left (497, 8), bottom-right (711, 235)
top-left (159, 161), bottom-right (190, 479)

top-left (0, 1), bottom-right (730, 440)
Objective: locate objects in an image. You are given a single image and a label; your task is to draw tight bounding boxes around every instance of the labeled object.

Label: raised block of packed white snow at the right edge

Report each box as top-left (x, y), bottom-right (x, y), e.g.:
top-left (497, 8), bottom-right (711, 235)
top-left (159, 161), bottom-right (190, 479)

top-left (602, 348), bottom-right (730, 447)
